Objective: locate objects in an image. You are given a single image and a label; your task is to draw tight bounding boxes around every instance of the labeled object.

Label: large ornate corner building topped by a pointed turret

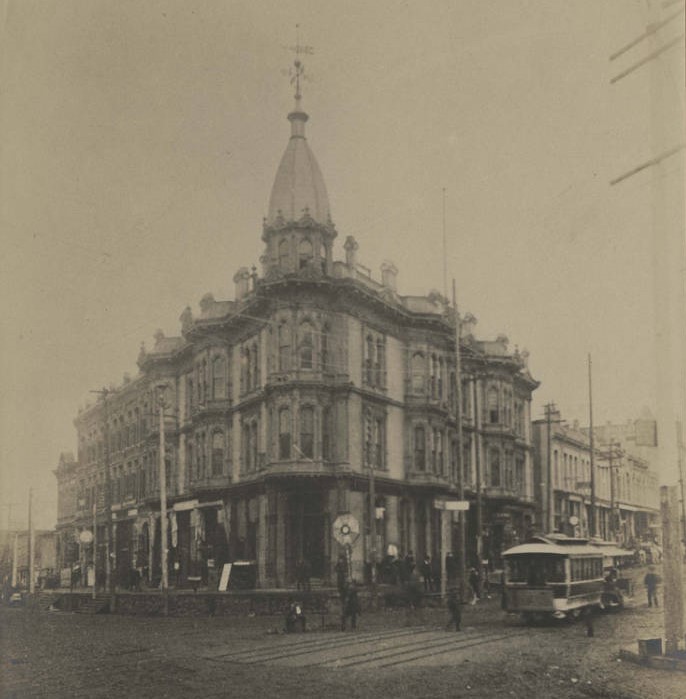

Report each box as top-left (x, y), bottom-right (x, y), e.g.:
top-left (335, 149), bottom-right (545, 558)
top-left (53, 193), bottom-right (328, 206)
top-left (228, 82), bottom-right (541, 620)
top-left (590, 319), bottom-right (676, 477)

top-left (56, 79), bottom-right (538, 587)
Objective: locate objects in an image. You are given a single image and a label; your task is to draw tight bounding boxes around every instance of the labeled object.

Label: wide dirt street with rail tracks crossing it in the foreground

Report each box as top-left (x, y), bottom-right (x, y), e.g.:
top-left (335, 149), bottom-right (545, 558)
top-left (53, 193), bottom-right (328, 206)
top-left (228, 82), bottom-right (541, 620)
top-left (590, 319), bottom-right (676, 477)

top-left (0, 596), bottom-right (686, 699)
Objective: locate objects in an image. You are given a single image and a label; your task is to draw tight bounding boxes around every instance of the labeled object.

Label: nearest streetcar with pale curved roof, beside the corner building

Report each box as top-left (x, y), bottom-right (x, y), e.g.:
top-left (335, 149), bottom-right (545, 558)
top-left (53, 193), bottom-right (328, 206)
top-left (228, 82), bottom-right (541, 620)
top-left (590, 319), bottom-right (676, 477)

top-left (503, 534), bottom-right (605, 621)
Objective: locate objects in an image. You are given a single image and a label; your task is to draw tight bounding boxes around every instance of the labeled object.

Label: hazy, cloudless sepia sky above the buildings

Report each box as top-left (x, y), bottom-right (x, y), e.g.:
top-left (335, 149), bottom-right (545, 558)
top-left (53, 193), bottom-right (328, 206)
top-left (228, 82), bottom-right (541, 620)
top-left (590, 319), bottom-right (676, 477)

top-left (0, 0), bottom-right (684, 527)
